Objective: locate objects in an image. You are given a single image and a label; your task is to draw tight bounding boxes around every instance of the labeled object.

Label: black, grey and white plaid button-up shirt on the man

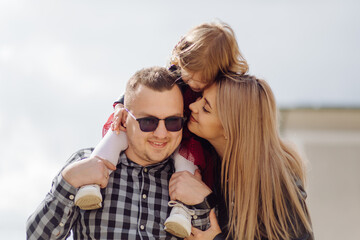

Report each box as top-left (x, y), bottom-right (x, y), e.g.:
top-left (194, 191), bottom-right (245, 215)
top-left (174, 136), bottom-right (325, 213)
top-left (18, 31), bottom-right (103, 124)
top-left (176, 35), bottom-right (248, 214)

top-left (27, 148), bottom-right (210, 239)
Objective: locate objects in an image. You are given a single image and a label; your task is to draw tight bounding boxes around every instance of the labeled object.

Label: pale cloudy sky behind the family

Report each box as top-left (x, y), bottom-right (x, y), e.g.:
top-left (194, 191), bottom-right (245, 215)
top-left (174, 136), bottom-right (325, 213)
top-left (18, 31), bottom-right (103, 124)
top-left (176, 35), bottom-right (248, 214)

top-left (0, 0), bottom-right (360, 239)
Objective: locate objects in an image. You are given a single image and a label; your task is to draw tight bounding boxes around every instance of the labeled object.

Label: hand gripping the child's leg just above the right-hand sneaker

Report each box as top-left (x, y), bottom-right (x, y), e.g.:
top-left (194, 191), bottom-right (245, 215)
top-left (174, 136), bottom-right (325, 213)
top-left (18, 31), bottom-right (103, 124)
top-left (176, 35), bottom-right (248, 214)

top-left (169, 170), bottom-right (211, 205)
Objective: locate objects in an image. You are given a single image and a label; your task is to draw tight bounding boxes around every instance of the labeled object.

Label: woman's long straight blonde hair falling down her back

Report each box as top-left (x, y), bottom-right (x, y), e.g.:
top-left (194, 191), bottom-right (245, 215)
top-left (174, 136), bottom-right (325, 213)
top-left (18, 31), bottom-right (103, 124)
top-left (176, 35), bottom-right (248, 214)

top-left (217, 75), bottom-right (312, 240)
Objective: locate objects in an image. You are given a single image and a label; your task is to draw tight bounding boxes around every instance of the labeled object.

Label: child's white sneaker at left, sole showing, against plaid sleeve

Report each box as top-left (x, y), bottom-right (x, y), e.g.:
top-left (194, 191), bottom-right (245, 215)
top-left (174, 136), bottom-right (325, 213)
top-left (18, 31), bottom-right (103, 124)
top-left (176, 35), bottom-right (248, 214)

top-left (75, 184), bottom-right (102, 210)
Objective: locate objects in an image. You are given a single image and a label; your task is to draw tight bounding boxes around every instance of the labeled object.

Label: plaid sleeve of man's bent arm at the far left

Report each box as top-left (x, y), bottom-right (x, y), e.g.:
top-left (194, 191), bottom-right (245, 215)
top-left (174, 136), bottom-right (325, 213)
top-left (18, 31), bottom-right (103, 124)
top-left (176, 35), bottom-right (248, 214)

top-left (26, 149), bottom-right (92, 239)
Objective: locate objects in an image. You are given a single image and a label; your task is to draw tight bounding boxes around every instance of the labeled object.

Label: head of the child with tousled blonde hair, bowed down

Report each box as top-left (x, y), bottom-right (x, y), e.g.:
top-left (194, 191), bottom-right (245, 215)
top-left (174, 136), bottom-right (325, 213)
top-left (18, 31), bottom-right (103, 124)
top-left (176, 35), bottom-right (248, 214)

top-left (171, 22), bottom-right (248, 84)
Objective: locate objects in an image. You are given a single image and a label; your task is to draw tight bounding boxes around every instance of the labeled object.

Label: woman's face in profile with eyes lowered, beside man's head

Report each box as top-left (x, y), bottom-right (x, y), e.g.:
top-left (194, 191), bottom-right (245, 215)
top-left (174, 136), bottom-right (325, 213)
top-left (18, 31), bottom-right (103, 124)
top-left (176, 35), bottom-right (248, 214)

top-left (188, 84), bottom-right (224, 142)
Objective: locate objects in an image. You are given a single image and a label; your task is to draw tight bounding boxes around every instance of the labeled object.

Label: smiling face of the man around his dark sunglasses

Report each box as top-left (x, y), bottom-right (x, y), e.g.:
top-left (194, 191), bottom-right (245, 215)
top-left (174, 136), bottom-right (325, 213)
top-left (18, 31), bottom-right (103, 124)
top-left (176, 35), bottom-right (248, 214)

top-left (125, 85), bottom-right (184, 166)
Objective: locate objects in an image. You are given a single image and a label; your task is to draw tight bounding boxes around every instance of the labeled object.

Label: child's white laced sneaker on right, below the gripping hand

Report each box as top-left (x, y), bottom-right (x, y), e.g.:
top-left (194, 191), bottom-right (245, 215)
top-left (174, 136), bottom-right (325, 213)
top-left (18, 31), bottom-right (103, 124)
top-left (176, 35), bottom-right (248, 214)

top-left (164, 201), bottom-right (194, 238)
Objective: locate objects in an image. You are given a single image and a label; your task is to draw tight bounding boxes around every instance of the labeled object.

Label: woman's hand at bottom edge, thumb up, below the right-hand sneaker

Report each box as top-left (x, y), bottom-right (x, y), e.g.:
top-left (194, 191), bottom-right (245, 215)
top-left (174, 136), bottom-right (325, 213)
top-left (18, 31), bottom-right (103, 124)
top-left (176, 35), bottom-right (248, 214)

top-left (184, 209), bottom-right (221, 240)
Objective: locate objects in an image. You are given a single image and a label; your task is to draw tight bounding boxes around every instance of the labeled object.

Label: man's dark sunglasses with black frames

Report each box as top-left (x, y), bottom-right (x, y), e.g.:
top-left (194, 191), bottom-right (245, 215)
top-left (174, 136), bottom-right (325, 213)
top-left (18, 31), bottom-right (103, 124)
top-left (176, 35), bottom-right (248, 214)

top-left (125, 108), bottom-right (186, 132)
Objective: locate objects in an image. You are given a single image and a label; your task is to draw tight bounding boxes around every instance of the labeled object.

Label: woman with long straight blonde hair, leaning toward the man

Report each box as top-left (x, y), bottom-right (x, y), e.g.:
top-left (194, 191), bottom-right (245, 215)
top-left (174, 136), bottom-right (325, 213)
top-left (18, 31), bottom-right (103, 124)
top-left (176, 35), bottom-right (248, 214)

top-left (169, 75), bottom-right (313, 239)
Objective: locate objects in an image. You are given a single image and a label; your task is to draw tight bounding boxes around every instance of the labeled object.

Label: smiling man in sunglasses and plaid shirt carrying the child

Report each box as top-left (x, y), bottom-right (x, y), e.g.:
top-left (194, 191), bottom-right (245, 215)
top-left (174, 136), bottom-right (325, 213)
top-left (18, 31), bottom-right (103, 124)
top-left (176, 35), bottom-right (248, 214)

top-left (27, 67), bottom-right (209, 239)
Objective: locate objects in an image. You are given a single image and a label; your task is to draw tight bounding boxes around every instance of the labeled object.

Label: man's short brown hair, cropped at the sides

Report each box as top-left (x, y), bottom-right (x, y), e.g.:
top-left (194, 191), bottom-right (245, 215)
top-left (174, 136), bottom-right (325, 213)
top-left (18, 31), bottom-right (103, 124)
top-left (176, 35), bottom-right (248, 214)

top-left (125, 67), bottom-right (177, 107)
